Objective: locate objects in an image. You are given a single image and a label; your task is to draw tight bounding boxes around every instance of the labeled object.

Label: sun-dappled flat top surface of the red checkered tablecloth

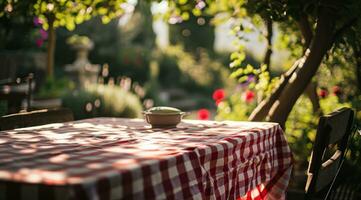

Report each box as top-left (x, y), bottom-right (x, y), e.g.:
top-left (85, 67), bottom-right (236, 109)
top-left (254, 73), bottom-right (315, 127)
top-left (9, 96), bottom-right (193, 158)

top-left (0, 118), bottom-right (290, 200)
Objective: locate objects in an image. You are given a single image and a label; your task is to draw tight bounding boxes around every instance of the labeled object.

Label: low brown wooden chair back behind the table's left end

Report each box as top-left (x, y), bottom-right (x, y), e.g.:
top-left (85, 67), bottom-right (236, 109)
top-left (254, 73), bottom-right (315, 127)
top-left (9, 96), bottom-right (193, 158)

top-left (0, 108), bottom-right (74, 130)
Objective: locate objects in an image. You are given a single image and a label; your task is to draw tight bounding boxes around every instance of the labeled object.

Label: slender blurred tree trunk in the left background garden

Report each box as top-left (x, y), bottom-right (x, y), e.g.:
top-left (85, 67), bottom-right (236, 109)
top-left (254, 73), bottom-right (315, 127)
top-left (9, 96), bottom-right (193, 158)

top-left (46, 17), bottom-right (56, 78)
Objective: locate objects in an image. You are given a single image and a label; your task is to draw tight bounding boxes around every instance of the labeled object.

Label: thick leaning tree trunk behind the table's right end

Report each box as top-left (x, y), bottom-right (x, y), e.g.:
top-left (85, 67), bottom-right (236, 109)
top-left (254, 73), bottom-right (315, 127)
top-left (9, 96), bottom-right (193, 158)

top-left (268, 6), bottom-right (335, 127)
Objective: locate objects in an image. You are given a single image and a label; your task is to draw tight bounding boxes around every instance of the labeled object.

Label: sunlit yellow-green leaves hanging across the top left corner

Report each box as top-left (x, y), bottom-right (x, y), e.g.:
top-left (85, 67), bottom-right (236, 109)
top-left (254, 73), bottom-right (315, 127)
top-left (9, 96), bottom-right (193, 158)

top-left (0, 0), bottom-right (126, 30)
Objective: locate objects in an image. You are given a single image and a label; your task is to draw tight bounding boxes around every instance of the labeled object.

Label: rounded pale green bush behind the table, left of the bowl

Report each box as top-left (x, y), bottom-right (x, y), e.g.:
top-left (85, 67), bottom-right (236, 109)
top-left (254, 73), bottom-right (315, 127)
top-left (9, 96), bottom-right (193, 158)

top-left (62, 84), bottom-right (142, 119)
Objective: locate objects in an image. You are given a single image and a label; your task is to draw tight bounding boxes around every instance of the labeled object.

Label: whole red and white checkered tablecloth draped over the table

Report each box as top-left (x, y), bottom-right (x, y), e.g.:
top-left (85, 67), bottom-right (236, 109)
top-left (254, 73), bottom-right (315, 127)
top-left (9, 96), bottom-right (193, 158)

top-left (0, 118), bottom-right (292, 200)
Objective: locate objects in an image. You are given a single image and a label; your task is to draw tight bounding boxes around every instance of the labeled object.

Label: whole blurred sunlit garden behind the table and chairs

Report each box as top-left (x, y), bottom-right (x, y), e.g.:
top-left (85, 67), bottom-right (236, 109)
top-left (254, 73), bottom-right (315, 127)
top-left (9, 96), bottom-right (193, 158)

top-left (0, 0), bottom-right (361, 192)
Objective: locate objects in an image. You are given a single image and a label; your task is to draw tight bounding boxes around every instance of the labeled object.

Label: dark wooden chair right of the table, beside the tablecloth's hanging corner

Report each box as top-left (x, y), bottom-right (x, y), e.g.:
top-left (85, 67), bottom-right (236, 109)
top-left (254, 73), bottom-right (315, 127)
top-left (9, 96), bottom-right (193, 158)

top-left (305, 108), bottom-right (354, 199)
